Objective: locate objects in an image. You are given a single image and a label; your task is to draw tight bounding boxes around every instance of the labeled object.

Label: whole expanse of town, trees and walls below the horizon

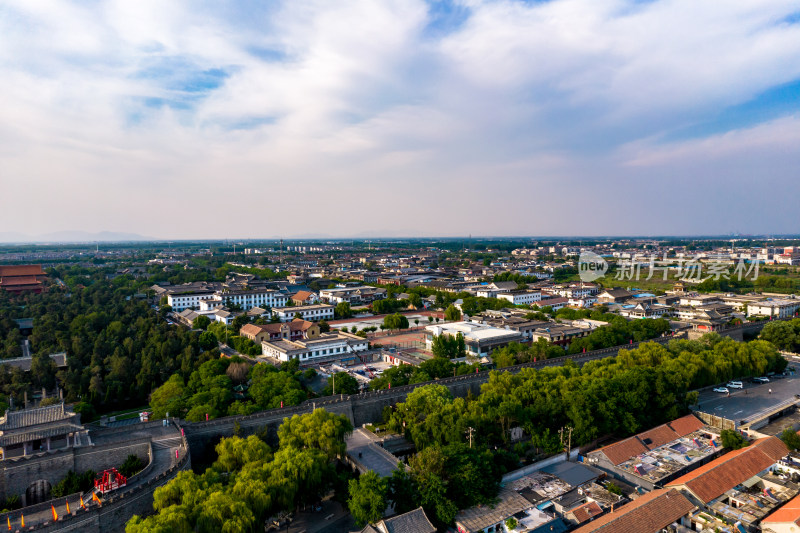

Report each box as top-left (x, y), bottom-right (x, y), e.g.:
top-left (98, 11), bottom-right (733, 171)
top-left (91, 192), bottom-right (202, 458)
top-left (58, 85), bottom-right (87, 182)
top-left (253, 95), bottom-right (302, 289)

top-left (0, 237), bottom-right (800, 533)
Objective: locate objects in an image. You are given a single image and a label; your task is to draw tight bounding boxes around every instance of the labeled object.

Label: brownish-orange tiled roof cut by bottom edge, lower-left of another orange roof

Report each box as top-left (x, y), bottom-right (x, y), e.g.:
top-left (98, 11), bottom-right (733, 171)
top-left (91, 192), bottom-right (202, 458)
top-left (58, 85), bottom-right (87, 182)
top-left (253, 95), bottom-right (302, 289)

top-left (575, 489), bottom-right (695, 533)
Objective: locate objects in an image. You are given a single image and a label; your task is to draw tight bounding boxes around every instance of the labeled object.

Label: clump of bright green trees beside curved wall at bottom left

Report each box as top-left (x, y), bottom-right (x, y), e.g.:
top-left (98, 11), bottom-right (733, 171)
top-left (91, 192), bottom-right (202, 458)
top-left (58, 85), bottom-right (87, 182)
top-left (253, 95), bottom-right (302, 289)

top-left (125, 409), bottom-right (353, 533)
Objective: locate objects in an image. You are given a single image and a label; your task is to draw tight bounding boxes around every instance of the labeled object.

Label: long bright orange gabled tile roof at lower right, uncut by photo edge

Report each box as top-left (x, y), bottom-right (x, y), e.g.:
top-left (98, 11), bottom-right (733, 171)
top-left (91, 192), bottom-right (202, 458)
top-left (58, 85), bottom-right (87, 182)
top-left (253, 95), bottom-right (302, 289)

top-left (667, 437), bottom-right (789, 503)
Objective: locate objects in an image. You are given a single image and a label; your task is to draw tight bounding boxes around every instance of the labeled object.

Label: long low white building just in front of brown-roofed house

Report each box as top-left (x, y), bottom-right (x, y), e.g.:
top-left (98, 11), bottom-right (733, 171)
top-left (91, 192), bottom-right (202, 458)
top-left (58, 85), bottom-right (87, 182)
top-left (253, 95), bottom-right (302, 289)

top-left (261, 331), bottom-right (369, 364)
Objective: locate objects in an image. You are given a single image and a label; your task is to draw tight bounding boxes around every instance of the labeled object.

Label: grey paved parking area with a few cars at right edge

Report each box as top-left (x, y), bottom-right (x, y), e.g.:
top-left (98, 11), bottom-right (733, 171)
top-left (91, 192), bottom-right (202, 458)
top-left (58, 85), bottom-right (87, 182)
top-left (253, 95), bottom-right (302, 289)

top-left (699, 375), bottom-right (800, 422)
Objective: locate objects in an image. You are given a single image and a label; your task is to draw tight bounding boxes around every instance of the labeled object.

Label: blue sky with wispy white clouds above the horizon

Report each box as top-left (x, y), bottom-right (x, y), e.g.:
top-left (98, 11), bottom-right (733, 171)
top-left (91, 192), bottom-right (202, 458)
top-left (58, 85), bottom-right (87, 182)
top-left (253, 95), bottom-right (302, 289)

top-left (0, 0), bottom-right (800, 239)
